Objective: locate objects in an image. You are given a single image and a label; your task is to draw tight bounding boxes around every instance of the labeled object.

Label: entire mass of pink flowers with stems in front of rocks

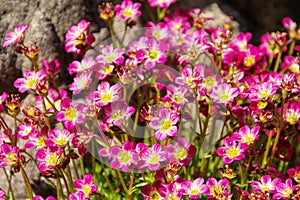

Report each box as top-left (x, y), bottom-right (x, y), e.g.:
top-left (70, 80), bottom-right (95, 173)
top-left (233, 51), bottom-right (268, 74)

top-left (0, 0), bottom-right (300, 200)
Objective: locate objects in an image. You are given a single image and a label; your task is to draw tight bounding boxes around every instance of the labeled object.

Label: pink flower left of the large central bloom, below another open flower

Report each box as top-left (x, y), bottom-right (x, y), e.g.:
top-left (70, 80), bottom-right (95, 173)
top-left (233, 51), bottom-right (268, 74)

top-left (104, 102), bottom-right (135, 126)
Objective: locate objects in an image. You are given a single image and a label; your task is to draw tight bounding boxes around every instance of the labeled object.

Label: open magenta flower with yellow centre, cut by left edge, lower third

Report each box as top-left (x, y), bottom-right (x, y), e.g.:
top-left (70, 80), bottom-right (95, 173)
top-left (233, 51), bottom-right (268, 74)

top-left (0, 143), bottom-right (19, 168)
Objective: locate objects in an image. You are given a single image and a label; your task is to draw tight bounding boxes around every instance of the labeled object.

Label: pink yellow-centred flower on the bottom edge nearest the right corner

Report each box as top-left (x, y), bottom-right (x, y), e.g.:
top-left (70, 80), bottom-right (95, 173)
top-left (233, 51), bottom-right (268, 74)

top-left (273, 178), bottom-right (297, 200)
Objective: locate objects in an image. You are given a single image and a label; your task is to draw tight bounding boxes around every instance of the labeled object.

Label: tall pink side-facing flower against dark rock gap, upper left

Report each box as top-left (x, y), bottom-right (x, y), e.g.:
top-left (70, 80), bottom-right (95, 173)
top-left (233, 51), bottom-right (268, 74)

top-left (65, 19), bottom-right (95, 55)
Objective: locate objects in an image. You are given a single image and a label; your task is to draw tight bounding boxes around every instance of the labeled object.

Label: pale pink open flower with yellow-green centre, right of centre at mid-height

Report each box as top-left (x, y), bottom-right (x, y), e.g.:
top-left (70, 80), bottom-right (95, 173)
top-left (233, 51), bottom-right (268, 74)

top-left (210, 83), bottom-right (239, 105)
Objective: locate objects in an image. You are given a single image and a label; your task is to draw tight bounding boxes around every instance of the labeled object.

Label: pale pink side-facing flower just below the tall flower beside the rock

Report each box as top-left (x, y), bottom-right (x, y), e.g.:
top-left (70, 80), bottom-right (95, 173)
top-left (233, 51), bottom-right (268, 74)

top-left (68, 56), bottom-right (97, 75)
